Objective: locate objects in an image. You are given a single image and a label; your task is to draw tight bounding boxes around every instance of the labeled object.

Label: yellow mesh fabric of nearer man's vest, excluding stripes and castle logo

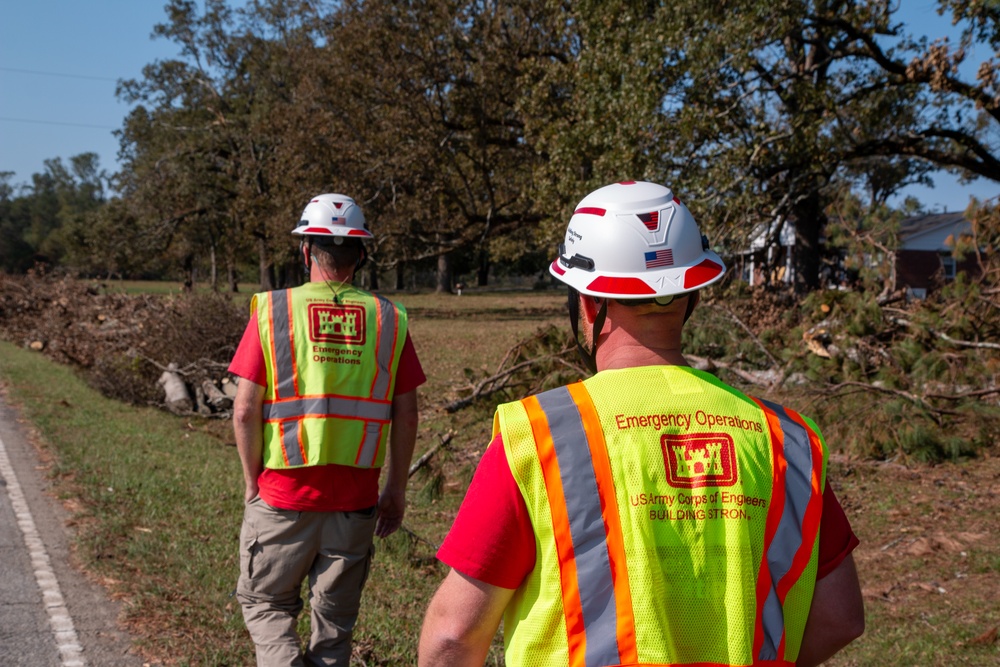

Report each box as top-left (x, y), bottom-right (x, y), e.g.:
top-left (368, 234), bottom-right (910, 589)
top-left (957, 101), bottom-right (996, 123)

top-left (494, 366), bottom-right (816, 667)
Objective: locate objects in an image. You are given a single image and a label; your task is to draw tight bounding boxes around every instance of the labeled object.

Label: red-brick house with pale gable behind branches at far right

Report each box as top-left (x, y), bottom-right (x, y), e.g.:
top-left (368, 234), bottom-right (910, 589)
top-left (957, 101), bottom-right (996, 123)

top-left (896, 212), bottom-right (979, 299)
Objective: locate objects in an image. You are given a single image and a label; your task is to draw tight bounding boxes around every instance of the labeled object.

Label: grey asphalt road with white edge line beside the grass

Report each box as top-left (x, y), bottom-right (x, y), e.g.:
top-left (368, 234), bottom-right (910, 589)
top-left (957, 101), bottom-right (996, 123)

top-left (0, 392), bottom-right (144, 667)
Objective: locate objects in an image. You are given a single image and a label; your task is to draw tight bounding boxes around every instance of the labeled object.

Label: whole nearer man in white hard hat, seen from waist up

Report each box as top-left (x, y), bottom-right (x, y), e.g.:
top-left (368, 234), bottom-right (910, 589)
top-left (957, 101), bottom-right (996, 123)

top-left (418, 181), bottom-right (864, 667)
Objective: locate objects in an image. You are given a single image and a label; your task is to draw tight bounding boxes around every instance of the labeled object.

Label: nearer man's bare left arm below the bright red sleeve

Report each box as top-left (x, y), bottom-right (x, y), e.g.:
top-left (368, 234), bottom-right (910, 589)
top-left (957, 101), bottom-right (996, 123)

top-left (417, 569), bottom-right (514, 667)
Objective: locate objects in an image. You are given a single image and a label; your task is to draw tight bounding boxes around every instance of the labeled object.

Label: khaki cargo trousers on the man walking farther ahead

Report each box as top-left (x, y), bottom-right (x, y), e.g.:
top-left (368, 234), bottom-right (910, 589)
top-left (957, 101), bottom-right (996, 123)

top-left (236, 496), bottom-right (375, 667)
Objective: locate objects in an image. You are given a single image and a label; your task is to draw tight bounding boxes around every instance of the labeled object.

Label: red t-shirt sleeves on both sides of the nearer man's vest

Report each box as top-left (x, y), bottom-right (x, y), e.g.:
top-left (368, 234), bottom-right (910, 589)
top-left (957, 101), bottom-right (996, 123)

top-left (437, 434), bottom-right (858, 589)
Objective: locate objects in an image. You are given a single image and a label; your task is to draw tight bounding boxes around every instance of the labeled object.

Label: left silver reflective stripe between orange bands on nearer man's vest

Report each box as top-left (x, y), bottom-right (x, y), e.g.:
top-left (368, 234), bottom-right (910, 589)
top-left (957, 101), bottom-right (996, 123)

top-left (537, 387), bottom-right (620, 667)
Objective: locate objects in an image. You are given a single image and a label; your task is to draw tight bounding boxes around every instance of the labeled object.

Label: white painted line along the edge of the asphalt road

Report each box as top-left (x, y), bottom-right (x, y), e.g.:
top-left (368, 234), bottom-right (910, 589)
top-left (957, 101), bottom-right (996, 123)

top-left (0, 430), bottom-right (87, 667)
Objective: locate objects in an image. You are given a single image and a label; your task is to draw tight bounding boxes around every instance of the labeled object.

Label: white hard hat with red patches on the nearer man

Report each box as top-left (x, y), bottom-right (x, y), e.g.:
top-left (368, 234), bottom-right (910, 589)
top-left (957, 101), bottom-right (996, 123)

top-left (549, 181), bottom-right (726, 299)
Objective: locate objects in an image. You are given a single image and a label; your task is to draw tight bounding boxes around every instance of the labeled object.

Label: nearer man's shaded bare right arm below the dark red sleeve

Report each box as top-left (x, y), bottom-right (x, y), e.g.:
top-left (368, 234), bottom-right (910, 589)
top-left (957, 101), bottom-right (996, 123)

top-left (795, 554), bottom-right (865, 667)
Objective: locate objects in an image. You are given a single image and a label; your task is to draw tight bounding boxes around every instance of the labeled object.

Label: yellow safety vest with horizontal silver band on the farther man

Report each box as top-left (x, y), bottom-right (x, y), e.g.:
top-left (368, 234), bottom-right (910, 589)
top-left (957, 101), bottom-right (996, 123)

top-left (250, 282), bottom-right (407, 468)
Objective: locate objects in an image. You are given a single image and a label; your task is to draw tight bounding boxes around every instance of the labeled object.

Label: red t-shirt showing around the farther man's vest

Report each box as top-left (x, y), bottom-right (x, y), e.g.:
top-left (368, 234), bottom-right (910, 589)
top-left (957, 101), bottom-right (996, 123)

top-left (229, 313), bottom-right (427, 512)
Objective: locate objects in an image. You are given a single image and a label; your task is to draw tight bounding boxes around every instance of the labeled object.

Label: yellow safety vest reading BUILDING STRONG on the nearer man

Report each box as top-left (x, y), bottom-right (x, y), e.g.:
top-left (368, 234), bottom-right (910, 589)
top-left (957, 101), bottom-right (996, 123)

top-left (493, 366), bottom-right (827, 667)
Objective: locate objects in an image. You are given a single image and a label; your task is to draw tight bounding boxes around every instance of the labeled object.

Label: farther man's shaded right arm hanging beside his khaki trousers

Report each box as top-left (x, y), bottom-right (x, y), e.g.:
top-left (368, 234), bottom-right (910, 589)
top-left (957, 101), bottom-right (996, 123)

top-left (375, 389), bottom-right (418, 537)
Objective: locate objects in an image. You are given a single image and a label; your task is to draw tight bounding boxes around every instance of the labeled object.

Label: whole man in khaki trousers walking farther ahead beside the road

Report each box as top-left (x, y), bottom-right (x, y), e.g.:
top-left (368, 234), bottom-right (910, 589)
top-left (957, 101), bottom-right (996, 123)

top-left (229, 194), bottom-right (426, 667)
